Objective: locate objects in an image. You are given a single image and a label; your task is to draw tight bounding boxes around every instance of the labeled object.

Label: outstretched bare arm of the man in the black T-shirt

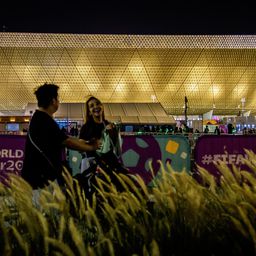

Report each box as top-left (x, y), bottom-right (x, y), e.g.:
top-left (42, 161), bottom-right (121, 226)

top-left (63, 137), bottom-right (101, 151)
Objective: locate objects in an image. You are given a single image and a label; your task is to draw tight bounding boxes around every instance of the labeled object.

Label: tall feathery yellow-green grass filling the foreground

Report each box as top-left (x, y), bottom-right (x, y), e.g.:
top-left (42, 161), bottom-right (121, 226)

top-left (0, 151), bottom-right (256, 256)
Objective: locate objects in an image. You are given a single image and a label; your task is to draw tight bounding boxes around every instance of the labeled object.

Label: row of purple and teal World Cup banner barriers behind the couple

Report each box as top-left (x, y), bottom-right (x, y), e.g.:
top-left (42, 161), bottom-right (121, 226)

top-left (0, 135), bottom-right (256, 184)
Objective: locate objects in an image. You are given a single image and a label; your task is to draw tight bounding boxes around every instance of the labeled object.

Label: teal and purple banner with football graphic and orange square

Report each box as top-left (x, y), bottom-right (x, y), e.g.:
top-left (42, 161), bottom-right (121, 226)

top-left (68, 135), bottom-right (190, 184)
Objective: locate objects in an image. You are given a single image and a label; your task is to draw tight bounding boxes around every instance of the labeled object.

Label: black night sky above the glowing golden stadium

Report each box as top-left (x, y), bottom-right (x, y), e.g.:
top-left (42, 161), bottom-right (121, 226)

top-left (0, 0), bottom-right (256, 35)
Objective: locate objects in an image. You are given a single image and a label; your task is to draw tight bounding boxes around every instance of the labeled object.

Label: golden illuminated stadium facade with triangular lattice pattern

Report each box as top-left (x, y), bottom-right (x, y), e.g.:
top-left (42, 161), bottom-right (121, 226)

top-left (0, 32), bottom-right (256, 115)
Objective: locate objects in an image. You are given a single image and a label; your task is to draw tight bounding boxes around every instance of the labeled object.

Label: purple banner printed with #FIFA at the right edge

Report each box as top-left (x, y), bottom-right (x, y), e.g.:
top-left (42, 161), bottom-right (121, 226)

top-left (194, 135), bottom-right (256, 177)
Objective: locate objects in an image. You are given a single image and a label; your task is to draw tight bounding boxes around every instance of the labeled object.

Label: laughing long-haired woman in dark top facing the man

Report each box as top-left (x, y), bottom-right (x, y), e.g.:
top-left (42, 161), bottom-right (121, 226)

top-left (79, 96), bottom-right (129, 194)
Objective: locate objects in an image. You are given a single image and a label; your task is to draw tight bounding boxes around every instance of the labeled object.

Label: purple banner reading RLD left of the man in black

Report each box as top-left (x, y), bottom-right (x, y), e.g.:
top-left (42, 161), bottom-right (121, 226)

top-left (0, 135), bottom-right (26, 181)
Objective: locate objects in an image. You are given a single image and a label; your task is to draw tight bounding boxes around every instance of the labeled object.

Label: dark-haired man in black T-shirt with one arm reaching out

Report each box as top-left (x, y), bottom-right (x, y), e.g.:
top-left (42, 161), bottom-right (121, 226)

top-left (21, 83), bottom-right (100, 189)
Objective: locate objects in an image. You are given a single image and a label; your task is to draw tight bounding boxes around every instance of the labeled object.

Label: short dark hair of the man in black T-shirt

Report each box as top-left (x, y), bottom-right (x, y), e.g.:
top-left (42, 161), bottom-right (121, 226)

top-left (34, 83), bottom-right (59, 108)
